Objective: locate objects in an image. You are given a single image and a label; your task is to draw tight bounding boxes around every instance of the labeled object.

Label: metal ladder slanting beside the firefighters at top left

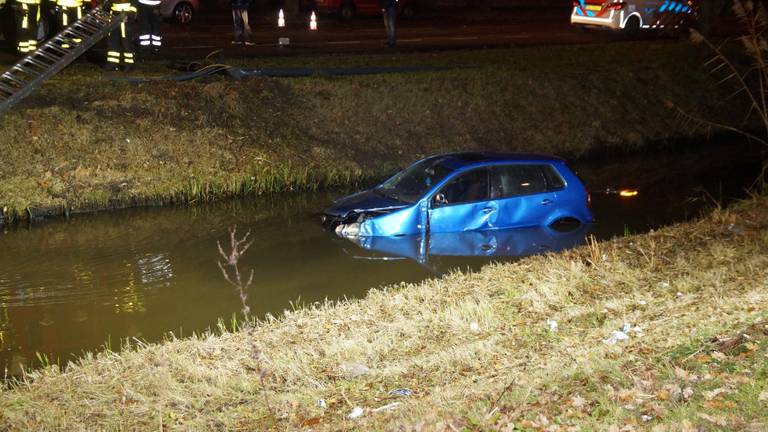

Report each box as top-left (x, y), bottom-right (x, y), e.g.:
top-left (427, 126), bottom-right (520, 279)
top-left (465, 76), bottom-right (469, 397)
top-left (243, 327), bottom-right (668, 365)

top-left (0, 7), bottom-right (125, 114)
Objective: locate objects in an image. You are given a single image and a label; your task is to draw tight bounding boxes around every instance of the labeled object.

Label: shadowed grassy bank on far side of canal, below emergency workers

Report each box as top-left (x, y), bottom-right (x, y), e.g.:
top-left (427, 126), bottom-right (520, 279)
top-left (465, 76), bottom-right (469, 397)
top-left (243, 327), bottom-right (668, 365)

top-left (0, 43), bottom-right (742, 218)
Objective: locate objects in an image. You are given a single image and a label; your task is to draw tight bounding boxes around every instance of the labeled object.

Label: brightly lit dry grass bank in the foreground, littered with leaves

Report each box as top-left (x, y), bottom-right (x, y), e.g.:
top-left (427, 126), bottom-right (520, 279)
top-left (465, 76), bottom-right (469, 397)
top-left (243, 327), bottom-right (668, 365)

top-left (0, 197), bottom-right (768, 431)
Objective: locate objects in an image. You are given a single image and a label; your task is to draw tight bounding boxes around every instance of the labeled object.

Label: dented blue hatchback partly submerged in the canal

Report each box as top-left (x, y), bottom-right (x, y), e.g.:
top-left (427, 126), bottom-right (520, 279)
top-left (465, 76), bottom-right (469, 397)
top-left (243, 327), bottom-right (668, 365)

top-left (323, 152), bottom-right (592, 237)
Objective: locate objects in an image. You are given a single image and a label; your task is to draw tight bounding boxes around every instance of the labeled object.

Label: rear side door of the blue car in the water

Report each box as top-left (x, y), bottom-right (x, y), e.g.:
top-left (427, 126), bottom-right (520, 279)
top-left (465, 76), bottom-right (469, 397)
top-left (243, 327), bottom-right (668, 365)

top-left (490, 164), bottom-right (557, 228)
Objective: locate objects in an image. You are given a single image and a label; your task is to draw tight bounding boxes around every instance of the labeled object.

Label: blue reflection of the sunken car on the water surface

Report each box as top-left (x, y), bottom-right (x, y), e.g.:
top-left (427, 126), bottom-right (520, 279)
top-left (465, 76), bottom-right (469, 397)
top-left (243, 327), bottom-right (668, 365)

top-left (350, 224), bottom-right (592, 264)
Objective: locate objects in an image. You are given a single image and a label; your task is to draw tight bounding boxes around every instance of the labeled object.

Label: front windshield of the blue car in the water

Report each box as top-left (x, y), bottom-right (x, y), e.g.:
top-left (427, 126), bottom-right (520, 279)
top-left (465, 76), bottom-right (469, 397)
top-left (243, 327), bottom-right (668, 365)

top-left (375, 158), bottom-right (453, 203)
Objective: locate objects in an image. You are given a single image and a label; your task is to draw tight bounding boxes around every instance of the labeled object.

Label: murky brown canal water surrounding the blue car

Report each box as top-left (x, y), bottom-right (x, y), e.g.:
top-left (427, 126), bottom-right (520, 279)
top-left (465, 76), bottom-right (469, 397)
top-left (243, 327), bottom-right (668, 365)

top-left (0, 141), bottom-right (759, 375)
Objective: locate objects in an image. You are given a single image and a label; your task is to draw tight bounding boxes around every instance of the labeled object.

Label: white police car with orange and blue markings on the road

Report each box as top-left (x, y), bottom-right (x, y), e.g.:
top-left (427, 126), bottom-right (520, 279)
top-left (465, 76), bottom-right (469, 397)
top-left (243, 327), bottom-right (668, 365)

top-left (571, 0), bottom-right (696, 34)
